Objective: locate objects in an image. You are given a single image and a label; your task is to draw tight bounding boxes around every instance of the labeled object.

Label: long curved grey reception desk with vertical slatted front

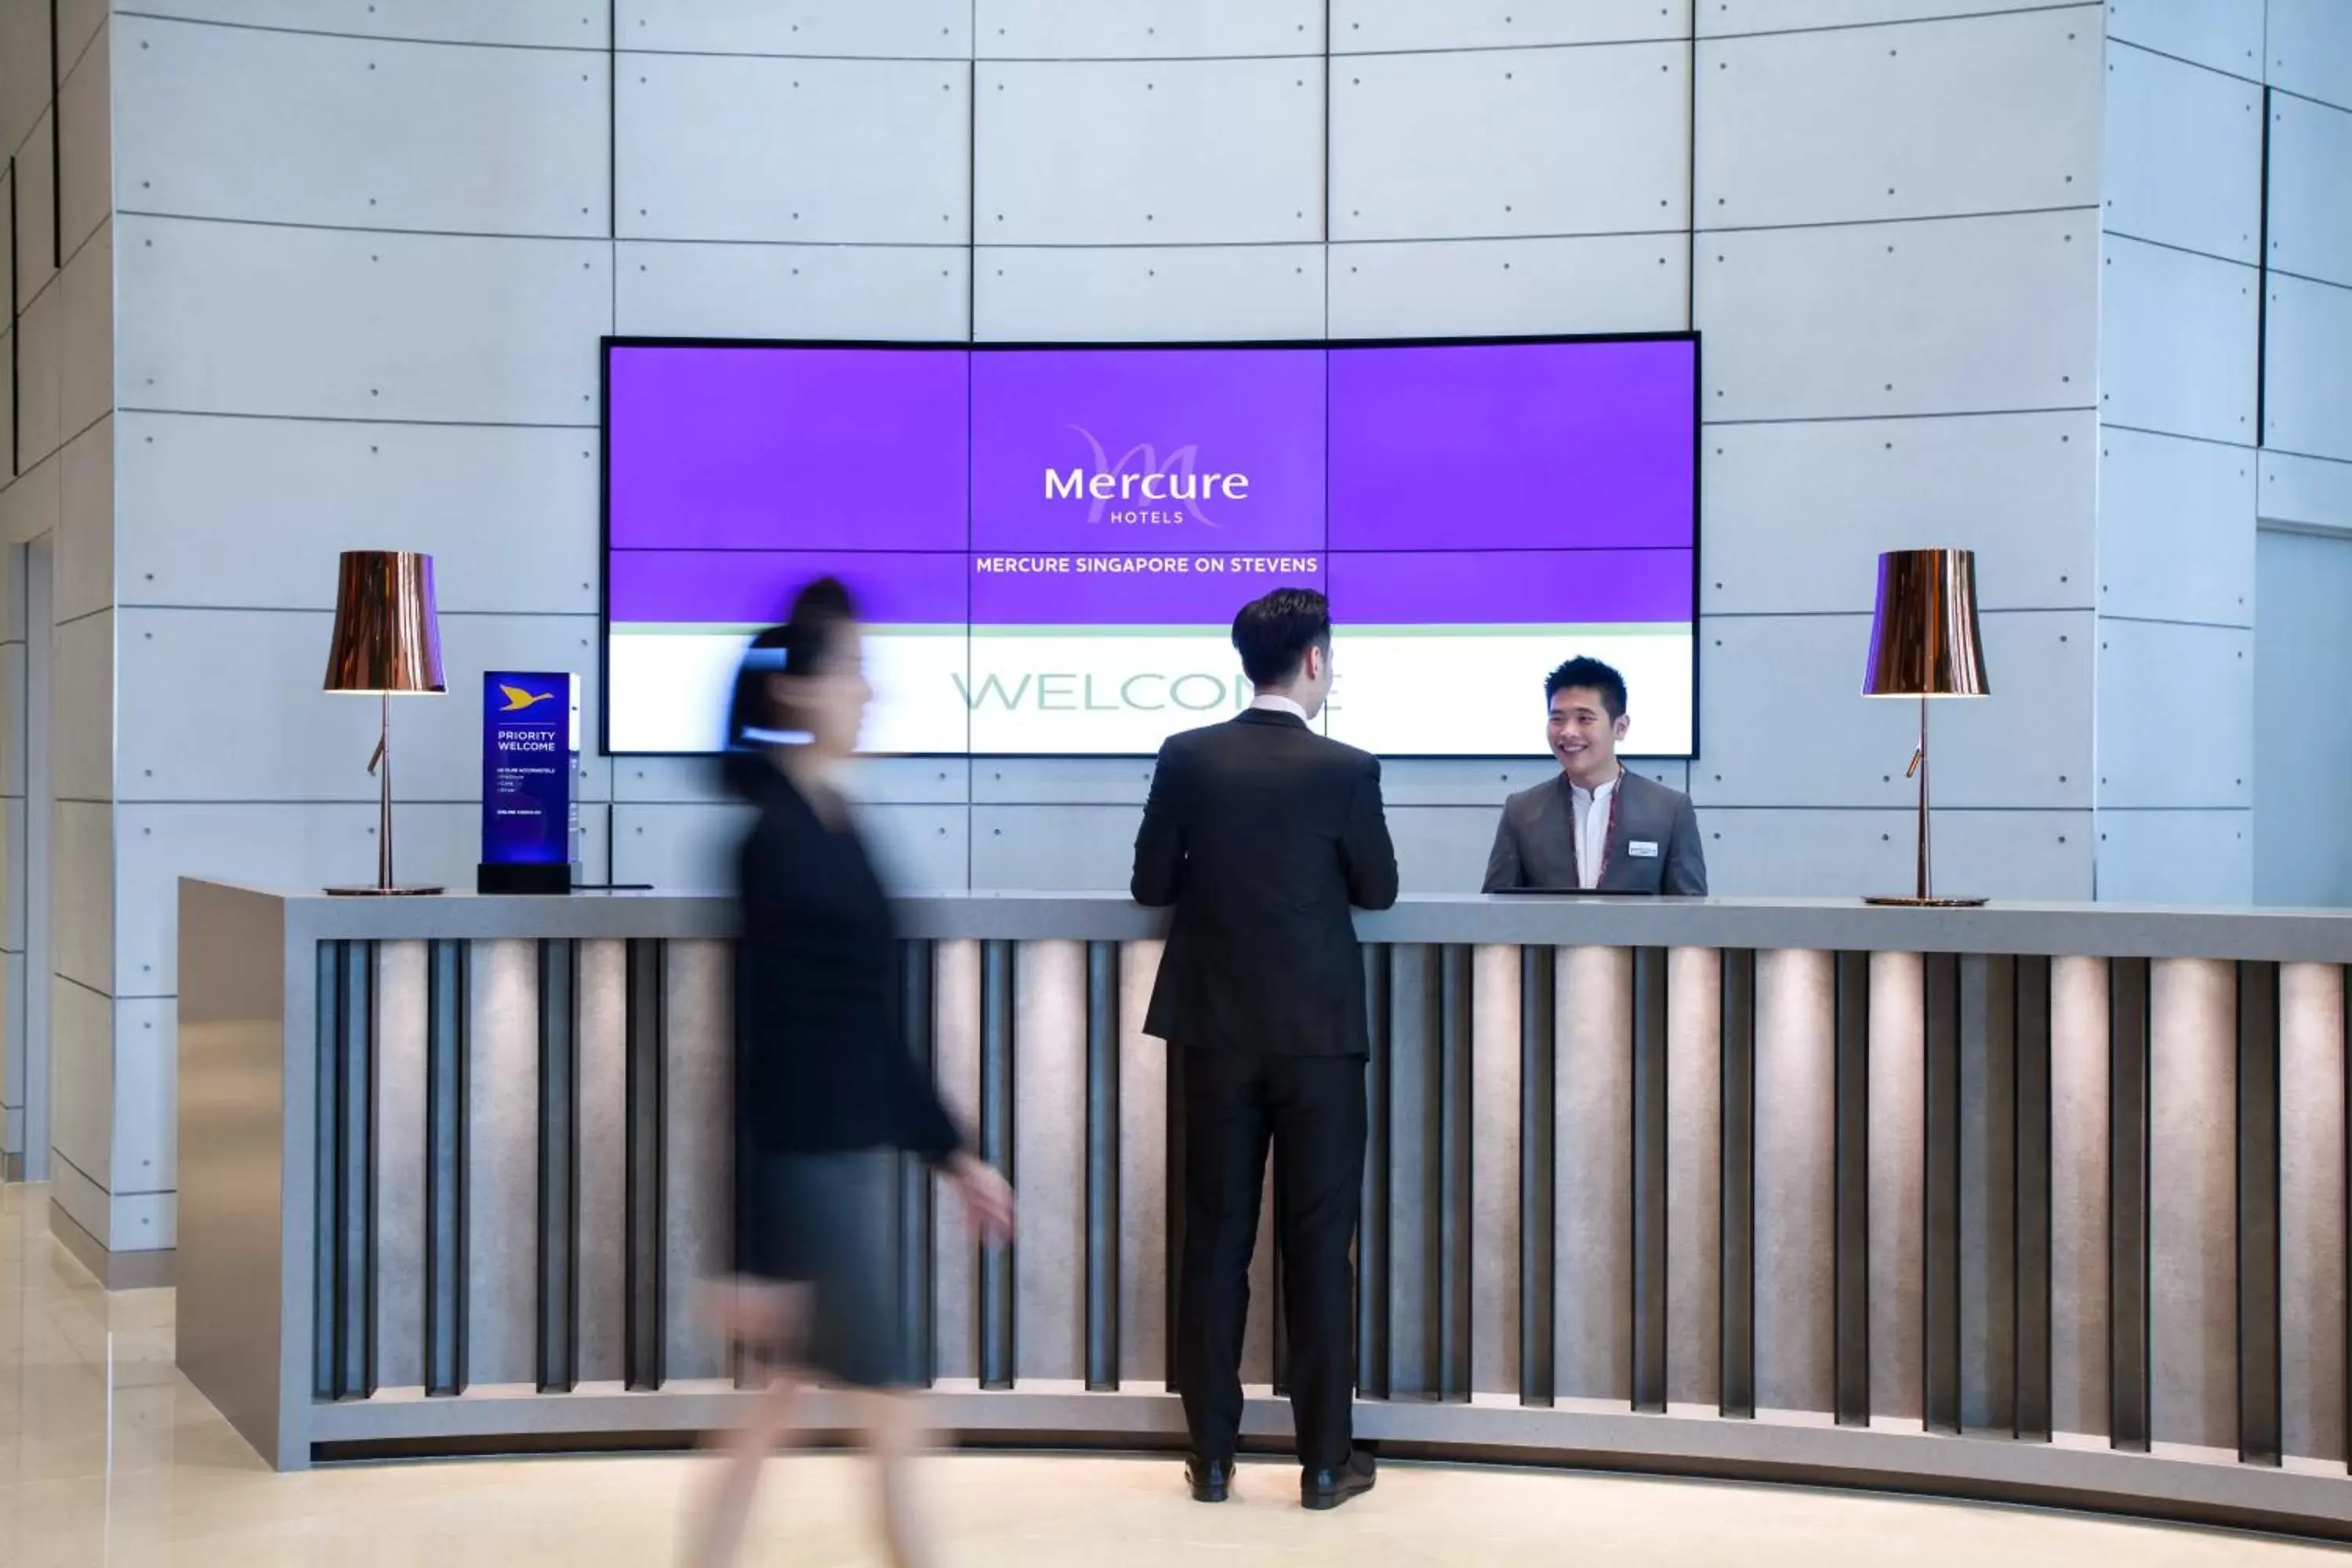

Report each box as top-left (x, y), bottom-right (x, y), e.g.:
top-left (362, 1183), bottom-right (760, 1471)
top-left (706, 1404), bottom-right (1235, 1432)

top-left (179, 881), bottom-right (2352, 1537)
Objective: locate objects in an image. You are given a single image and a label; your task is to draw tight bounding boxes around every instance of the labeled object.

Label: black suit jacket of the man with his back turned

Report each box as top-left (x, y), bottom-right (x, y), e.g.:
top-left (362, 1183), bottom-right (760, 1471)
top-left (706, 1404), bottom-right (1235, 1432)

top-left (1131, 708), bottom-right (1397, 1055)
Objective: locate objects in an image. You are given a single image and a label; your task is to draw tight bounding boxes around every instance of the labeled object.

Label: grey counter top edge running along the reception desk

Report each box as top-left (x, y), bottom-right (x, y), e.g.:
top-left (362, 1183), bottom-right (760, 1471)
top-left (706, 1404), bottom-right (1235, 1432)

top-left (188, 884), bottom-right (2352, 964)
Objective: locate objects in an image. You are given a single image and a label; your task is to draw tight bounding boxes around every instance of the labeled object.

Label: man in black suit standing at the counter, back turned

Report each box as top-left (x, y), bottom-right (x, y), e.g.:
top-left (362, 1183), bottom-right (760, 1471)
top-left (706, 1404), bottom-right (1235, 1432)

top-left (1134, 588), bottom-right (1397, 1509)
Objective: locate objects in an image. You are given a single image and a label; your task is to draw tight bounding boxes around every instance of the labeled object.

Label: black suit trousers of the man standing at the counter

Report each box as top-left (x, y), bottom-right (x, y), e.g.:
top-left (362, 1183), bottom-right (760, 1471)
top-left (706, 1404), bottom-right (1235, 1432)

top-left (1176, 1051), bottom-right (1364, 1469)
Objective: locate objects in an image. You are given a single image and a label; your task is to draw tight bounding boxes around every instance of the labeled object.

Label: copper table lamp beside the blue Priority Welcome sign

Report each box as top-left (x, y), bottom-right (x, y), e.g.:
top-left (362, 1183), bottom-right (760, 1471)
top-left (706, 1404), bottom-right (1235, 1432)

top-left (327, 550), bottom-right (447, 898)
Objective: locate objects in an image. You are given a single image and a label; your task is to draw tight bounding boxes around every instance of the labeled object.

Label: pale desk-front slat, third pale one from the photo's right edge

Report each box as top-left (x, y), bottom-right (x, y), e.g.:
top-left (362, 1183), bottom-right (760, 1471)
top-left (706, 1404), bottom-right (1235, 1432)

top-left (2051, 959), bottom-right (2114, 1436)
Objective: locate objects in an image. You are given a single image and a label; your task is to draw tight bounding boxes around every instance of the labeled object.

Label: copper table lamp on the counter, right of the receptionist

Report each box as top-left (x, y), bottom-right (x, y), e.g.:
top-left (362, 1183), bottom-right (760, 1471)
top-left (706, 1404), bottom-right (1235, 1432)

top-left (1863, 550), bottom-right (1990, 907)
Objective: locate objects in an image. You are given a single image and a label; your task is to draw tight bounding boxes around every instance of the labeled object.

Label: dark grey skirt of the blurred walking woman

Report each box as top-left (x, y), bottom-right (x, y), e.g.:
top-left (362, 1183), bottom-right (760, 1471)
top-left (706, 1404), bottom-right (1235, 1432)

top-left (739, 1149), bottom-right (915, 1389)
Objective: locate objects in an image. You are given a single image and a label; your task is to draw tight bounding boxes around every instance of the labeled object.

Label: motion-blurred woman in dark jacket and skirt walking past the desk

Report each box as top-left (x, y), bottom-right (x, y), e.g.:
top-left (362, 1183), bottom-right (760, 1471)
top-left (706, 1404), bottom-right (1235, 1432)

top-left (689, 579), bottom-right (1011, 1568)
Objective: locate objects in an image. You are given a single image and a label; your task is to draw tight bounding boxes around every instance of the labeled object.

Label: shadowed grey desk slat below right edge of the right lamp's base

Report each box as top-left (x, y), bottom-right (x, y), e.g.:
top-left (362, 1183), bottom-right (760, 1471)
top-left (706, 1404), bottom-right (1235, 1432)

top-left (1959, 954), bottom-right (2018, 1434)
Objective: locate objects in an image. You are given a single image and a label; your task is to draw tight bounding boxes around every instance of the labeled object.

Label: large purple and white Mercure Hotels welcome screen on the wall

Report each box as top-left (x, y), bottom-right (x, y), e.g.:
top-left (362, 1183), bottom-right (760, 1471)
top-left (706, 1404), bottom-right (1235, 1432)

top-left (604, 336), bottom-right (1698, 757)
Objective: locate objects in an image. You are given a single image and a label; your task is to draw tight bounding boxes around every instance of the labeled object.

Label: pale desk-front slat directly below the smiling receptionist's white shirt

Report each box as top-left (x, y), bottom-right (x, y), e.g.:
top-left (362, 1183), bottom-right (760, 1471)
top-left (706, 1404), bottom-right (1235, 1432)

top-left (1552, 947), bottom-right (1632, 1403)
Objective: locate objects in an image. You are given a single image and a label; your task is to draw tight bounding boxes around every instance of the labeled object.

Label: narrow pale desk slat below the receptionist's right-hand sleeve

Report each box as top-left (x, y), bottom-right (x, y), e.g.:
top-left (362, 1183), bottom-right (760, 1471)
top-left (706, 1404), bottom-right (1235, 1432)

top-left (1665, 947), bottom-right (1724, 1408)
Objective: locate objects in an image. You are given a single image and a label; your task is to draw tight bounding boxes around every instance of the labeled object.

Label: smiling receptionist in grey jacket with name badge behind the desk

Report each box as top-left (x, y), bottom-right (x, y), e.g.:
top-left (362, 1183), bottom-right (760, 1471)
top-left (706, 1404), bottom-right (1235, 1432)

top-left (1486, 659), bottom-right (1708, 898)
